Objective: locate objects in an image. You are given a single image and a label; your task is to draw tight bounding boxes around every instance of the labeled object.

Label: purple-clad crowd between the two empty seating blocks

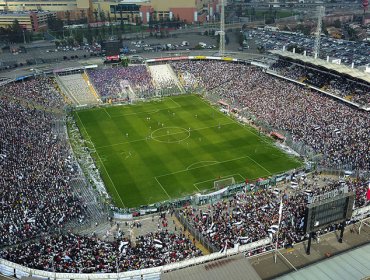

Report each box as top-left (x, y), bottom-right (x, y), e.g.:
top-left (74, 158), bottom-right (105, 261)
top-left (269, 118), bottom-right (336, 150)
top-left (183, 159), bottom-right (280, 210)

top-left (87, 65), bottom-right (154, 101)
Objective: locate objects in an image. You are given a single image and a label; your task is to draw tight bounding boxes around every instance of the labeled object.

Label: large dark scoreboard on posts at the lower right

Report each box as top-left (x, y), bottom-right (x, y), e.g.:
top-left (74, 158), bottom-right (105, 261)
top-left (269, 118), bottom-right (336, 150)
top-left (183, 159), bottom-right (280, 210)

top-left (304, 192), bottom-right (354, 233)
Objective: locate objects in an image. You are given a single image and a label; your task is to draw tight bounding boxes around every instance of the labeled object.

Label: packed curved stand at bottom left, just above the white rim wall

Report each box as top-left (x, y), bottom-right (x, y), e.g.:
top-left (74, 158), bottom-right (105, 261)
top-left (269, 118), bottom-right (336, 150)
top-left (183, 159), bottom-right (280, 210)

top-left (0, 230), bottom-right (202, 273)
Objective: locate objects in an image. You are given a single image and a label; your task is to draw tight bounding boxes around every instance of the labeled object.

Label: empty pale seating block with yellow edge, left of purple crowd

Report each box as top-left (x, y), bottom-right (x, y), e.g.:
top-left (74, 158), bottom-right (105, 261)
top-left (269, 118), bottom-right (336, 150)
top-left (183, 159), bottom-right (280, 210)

top-left (57, 73), bottom-right (100, 106)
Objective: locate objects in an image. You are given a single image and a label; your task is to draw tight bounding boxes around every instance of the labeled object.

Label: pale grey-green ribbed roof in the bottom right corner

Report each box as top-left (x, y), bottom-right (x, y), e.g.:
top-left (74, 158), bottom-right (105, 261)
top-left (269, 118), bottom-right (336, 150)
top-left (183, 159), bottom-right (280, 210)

top-left (276, 244), bottom-right (370, 280)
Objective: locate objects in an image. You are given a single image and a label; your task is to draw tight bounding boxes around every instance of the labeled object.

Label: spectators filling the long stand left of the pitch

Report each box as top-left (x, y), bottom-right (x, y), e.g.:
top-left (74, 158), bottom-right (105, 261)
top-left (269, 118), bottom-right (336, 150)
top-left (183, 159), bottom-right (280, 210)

top-left (0, 78), bottom-right (83, 246)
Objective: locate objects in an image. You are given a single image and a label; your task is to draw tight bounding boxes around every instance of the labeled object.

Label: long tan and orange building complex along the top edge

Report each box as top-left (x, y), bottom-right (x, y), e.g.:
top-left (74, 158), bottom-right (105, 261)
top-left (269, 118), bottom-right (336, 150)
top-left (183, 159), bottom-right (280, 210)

top-left (0, 0), bottom-right (220, 24)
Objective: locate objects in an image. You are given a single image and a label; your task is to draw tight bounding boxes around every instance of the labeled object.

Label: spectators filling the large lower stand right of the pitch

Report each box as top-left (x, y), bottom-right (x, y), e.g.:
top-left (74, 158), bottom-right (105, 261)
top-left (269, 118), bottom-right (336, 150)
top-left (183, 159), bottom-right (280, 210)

top-left (172, 61), bottom-right (370, 170)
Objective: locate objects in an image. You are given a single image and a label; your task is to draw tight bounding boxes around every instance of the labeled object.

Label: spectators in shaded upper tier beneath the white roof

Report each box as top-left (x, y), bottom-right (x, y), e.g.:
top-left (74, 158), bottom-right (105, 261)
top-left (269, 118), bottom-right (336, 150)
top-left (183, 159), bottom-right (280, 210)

top-left (271, 59), bottom-right (370, 107)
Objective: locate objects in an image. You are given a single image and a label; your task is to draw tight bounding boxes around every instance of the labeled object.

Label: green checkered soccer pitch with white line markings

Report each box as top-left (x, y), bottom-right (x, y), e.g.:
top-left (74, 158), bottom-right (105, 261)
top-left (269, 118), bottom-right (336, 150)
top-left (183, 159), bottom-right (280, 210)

top-left (74, 95), bottom-right (301, 207)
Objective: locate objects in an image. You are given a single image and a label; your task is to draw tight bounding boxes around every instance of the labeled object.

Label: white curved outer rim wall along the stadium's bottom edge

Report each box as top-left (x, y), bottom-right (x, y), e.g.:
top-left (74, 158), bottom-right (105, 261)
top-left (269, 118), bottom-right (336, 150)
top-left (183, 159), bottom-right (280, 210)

top-left (0, 238), bottom-right (271, 280)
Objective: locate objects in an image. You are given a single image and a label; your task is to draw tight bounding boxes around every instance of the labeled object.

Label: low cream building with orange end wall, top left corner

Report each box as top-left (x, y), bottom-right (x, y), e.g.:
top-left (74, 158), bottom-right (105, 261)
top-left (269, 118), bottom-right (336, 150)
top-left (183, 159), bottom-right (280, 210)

top-left (0, 11), bottom-right (56, 32)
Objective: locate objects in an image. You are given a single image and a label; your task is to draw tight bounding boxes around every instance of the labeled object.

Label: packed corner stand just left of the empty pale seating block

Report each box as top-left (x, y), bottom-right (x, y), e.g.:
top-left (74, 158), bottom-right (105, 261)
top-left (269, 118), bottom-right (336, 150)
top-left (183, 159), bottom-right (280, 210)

top-left (0, 77), bottom-right (65, 109)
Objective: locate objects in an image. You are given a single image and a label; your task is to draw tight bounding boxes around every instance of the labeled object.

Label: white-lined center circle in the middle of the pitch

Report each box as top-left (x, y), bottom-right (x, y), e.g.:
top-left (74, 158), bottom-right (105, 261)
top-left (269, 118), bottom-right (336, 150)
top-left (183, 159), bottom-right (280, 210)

top-left (150, 126), bottom-right (190, 143)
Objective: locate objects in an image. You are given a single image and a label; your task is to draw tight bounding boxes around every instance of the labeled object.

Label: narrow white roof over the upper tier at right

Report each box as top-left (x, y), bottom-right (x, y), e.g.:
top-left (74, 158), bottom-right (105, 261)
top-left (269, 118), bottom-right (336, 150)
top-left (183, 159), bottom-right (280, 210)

top-left (270, 50), bottom-right (370, 83)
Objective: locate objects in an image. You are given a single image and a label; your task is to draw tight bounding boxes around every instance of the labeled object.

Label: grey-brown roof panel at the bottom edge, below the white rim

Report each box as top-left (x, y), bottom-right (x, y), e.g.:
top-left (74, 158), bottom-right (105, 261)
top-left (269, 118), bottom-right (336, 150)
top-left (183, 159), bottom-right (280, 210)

top-left (161, 254), bottom-right (261, 280)
